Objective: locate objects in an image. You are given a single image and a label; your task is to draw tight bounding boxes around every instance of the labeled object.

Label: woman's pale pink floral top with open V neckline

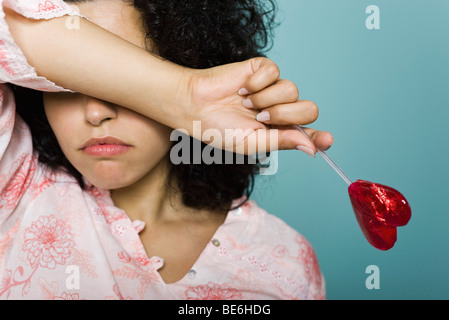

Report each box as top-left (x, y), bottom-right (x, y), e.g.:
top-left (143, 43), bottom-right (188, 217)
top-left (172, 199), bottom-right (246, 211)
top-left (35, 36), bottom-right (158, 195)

top-left (0, 0), bottom-right (325, 299)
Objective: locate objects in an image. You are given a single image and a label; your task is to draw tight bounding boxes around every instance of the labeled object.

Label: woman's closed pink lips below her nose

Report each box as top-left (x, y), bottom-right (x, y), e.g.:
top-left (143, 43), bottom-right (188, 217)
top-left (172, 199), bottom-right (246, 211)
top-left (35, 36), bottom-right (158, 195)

top-left (79, 137), bottom-right (132, 157)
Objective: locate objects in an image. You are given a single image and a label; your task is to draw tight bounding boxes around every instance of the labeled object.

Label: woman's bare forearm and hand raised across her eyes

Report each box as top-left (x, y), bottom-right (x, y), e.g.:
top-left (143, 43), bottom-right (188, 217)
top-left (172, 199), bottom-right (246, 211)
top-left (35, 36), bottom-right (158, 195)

top-left (3, 0), bottom-right (332, 154)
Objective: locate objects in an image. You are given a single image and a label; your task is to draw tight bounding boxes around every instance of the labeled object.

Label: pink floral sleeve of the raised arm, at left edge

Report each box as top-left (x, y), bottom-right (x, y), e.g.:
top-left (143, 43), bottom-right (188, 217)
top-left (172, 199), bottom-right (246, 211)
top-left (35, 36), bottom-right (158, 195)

top-left (0, 0), bottom-right (83, 226)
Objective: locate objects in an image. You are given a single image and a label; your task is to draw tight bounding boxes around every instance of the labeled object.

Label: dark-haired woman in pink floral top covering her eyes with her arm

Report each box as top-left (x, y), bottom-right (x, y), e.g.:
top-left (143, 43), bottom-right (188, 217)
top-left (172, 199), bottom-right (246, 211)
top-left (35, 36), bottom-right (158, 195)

top-left (0, 0), bottom-right (332, 299)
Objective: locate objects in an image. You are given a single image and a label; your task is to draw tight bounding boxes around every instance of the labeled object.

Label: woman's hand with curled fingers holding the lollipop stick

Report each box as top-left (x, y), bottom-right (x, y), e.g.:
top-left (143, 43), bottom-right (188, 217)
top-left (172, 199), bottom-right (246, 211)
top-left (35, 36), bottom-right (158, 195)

top-left (184, 58), bottom-right (333, 155)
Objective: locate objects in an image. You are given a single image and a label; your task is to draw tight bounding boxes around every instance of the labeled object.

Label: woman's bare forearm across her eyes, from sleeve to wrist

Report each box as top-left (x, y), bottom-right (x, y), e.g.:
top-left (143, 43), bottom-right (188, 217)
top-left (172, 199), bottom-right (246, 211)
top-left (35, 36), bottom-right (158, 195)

top-left (5, 8), bottom-right (190, 127)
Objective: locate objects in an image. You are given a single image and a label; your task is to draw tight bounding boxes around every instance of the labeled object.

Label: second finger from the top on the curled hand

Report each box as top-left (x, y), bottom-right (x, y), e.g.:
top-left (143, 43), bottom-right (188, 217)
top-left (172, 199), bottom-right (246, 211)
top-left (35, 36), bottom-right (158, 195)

top-left (243, 79), bottom-right (299, 109)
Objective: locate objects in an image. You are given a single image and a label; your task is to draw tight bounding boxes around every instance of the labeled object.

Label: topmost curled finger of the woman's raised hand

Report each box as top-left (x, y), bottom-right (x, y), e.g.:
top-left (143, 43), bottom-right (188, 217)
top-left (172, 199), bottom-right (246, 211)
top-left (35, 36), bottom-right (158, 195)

top-left (239, 58), bottom-right (280, 95)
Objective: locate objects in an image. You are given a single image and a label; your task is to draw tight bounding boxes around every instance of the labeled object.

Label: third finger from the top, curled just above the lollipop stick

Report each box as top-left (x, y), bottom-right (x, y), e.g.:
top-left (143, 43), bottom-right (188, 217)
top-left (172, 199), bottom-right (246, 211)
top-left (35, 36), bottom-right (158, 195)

top-left (256, 100), bottom-right (319, 125)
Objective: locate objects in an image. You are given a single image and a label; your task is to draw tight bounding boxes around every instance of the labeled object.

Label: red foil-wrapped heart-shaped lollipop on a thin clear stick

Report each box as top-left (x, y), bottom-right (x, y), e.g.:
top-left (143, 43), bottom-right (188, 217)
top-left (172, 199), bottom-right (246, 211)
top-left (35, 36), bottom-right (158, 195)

top-left (295, 126), bottom-right (412, 250)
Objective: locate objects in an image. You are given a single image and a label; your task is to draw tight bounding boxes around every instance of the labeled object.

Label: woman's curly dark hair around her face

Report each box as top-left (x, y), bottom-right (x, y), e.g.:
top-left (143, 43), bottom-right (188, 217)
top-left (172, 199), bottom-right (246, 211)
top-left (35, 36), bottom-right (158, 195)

top-left (13, 0), bottom-right (276, 210)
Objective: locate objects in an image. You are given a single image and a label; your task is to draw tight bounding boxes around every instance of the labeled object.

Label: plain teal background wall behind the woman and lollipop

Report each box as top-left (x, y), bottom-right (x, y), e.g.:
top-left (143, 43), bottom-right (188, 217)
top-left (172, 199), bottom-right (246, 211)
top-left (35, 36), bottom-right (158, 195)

top-left (252, 0), bottom-right (449, 299)
